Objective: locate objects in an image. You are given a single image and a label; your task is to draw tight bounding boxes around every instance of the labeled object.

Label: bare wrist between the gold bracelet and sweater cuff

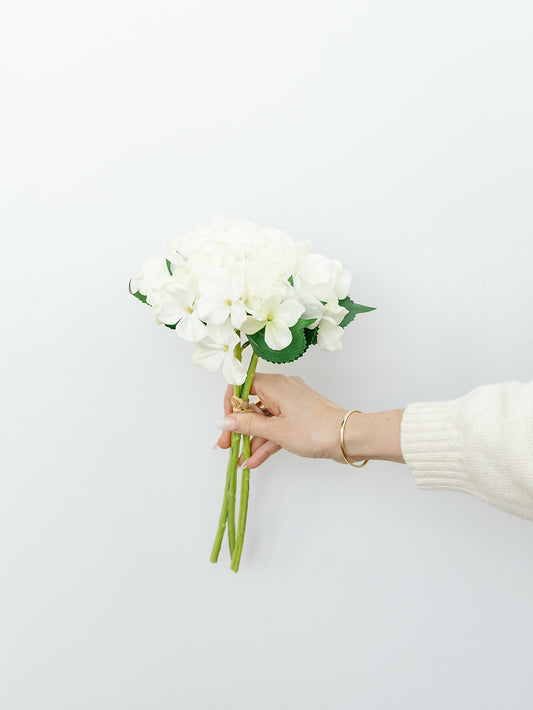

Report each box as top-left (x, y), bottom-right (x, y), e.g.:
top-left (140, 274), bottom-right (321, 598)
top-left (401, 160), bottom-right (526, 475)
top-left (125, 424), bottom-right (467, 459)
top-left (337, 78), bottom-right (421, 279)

top-left (339, 409), bottom-right (404, 463)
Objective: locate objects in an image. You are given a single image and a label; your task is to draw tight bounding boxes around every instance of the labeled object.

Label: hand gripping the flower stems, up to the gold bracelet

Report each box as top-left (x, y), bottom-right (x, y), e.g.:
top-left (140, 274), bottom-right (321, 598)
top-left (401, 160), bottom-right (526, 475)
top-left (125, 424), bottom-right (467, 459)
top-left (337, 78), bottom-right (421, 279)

top-left (217, 373), bottom-right (347, 468)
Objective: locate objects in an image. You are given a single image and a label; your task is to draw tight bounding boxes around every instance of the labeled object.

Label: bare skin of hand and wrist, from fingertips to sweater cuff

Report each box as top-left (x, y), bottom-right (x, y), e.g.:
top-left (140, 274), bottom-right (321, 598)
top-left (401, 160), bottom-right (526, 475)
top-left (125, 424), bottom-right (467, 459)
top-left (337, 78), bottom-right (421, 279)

top-left (217, 373), bottom-right (405, 468)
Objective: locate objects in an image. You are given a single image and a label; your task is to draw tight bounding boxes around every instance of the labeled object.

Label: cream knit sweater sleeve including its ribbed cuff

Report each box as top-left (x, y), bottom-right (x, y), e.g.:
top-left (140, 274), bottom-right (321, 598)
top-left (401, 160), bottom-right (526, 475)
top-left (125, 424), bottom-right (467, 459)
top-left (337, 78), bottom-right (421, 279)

top-left (401, 381), bottom-right (533, 520)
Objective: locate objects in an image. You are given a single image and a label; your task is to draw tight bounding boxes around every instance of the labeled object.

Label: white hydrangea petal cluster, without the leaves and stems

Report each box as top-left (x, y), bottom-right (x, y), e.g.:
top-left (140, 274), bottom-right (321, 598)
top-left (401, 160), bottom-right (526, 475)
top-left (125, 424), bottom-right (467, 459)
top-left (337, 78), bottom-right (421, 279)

top-left (132, 217), bottom-right (362, 384)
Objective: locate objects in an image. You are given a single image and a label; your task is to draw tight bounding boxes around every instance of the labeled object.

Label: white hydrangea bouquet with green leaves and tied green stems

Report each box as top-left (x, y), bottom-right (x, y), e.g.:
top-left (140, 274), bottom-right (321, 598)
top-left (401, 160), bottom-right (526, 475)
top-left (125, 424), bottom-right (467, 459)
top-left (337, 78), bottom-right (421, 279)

top-left (129, 218), bottom-right (374, 572)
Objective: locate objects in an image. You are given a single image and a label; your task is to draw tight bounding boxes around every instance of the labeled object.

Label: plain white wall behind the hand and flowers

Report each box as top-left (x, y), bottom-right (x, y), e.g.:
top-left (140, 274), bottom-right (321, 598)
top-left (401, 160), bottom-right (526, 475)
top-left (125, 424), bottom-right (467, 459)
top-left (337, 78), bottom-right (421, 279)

top-left (0, 0), bottom-right (533, 710)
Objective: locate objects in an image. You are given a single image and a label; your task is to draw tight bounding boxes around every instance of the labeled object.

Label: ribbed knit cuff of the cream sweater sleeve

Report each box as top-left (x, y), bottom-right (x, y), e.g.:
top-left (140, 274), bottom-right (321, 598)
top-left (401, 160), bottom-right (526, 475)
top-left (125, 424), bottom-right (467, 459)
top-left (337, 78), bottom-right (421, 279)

top-left (401, 400), bottom-right (472, 493)
